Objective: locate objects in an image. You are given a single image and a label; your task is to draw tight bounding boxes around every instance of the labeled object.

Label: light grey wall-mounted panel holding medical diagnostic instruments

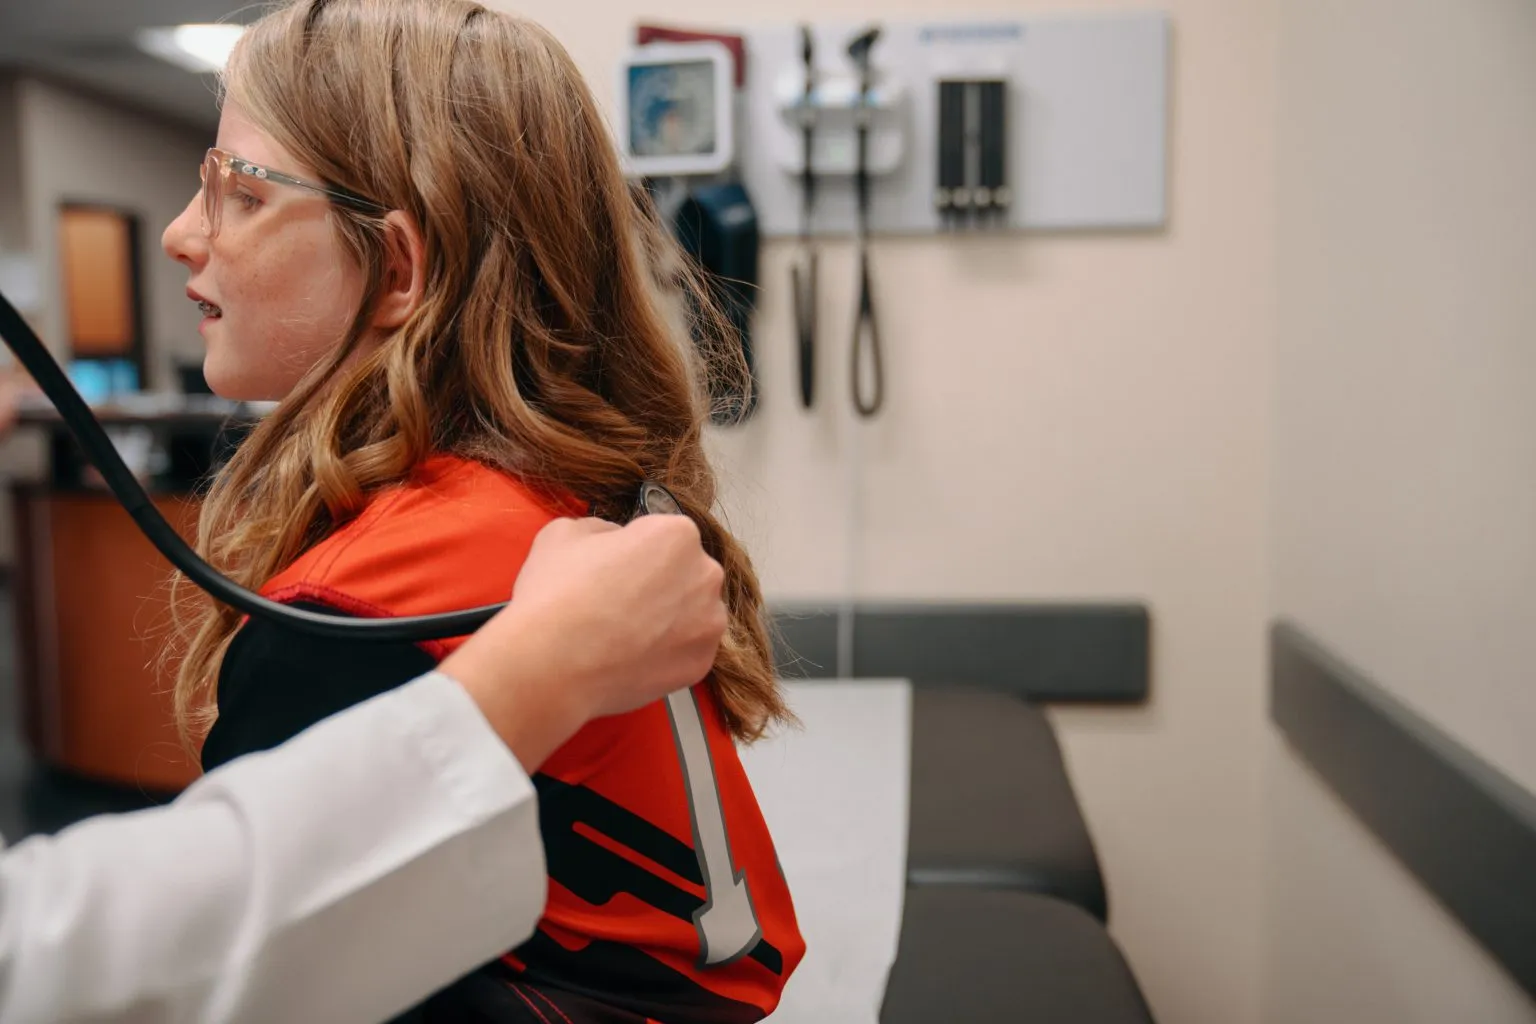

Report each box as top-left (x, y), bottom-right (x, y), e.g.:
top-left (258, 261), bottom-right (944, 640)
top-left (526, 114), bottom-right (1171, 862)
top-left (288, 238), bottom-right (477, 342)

top-left (739, 12), bottom-right (1169, 235)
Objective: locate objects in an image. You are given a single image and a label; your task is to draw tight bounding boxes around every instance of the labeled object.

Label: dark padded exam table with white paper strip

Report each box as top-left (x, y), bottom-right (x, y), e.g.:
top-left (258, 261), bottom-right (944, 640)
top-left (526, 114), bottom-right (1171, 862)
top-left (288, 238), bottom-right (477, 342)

top-left (755, 680), bottom-right (1152, 1024)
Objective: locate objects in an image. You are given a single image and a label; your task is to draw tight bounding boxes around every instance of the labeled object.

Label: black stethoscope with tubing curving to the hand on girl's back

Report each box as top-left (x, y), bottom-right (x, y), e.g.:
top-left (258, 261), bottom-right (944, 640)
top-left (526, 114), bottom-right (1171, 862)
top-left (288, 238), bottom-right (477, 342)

top-left (0, 288), bottom-right (682, 642)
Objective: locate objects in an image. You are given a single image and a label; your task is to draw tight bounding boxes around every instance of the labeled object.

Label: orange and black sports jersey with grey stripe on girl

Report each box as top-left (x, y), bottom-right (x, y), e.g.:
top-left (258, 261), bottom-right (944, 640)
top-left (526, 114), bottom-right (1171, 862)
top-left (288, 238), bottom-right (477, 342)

top-left (203, 456), bottom-right (805, 1024)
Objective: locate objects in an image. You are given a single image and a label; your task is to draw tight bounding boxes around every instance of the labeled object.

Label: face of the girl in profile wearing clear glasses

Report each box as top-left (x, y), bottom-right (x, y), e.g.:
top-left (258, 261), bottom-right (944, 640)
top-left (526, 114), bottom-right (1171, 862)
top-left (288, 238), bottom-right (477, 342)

top-left (161, 103), bottom-right (362, 401)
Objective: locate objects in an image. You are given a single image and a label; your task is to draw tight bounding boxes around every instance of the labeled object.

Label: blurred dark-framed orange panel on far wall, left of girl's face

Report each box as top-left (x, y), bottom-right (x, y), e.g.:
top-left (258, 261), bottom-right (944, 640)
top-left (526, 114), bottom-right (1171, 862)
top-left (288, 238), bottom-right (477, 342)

top-left (58, 203), bottom-right (146, 393)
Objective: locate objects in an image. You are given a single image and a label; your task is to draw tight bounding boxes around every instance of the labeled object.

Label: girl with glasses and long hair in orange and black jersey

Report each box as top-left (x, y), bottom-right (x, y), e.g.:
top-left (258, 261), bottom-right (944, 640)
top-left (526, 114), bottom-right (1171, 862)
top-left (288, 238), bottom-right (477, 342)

top-left (164, 0), bottom-right (805, 1024)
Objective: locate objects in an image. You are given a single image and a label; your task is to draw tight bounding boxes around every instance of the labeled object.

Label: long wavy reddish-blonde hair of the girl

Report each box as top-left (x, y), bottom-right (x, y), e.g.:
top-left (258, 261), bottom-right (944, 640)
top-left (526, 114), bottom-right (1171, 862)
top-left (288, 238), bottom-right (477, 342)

top-left (172, 0), bottom-right (786, 743)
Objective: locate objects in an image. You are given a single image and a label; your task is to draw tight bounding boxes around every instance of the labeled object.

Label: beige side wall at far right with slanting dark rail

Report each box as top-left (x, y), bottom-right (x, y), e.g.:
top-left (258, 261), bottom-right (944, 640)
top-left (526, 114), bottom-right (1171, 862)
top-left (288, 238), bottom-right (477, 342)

top-left (1266, 0), bottom-right (1536, 1024)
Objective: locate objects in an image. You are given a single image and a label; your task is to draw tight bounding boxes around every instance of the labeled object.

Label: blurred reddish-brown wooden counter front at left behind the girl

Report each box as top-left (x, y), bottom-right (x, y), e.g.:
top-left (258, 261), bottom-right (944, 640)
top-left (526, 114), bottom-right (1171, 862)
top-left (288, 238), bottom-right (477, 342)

top-left (14, 485), bottom-right (198, 794)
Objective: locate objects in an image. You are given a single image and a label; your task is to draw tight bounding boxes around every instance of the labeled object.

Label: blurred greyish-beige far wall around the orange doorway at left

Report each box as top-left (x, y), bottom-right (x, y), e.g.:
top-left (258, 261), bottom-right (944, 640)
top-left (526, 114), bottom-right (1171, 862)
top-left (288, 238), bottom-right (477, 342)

top-left (18, 80), bottom-right (212, 384)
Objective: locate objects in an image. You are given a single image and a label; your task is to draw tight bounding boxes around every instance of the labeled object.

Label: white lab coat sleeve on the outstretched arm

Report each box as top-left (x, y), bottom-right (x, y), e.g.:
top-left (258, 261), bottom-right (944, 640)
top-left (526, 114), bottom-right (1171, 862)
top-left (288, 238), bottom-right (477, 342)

top-left (0, 672), bottom-right (547, 1024)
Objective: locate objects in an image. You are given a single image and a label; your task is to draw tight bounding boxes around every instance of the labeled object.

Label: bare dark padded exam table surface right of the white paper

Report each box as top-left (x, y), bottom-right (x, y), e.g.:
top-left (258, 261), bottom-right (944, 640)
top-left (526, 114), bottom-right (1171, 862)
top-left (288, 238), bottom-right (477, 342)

top-left (880, 686), bottom-right (1152, 1024)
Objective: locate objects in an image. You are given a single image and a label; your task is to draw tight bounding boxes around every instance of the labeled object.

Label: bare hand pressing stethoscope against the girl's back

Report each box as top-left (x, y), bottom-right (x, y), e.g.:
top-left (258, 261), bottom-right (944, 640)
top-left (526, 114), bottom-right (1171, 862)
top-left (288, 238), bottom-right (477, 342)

top-left (441, 516), bottom-right (728, 772)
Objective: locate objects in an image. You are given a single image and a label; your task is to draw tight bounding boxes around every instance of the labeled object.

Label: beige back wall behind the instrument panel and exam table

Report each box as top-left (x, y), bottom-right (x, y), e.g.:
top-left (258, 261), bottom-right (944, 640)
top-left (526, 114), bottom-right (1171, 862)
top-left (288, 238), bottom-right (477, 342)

top-left (476, 0), bottom-right (1275, 1024)
